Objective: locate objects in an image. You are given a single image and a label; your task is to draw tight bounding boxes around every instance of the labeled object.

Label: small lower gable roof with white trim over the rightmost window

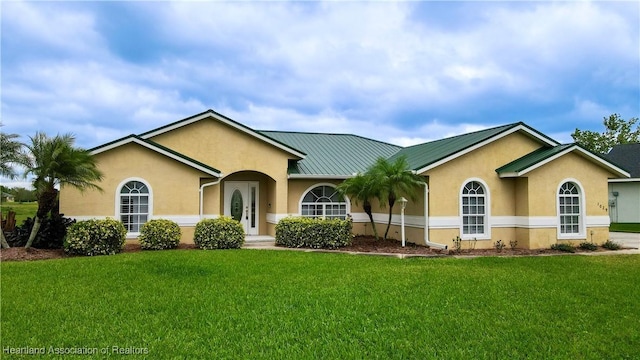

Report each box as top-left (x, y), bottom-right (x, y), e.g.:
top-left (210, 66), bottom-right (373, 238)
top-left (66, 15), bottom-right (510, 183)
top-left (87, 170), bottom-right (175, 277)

top-left (496, 144), bottom-right (629, 178)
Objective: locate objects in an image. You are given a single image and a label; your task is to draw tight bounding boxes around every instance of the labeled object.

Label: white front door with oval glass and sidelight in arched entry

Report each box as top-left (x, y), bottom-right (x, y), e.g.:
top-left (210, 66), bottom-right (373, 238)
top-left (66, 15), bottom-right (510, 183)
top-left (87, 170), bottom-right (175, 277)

top-left (224, 181), bottom-right (259, 235)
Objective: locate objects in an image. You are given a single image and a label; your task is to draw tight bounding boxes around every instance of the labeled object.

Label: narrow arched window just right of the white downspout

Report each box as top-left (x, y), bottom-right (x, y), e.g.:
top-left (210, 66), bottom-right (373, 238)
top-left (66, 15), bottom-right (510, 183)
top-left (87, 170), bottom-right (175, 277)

top-left (460, 180), bottom-right (489, 239)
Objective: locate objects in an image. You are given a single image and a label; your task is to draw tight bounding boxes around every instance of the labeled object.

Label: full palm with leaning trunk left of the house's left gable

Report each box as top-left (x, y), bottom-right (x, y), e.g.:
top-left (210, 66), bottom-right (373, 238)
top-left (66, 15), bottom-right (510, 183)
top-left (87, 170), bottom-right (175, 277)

top-left (25, 132), bottom-right (102, 249)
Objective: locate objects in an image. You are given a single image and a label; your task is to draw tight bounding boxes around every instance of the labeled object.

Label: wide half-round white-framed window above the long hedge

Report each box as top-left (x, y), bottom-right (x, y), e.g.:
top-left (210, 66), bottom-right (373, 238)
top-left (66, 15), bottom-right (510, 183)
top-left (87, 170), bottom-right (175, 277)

top-left (300, 185), bottom-right (348, 219)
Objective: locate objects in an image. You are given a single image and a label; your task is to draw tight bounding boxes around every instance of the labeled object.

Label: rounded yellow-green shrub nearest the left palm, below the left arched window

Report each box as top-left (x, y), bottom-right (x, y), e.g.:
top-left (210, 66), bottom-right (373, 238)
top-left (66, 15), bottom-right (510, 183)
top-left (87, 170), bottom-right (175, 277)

top-left (64, 219), bottom-right (127, 256)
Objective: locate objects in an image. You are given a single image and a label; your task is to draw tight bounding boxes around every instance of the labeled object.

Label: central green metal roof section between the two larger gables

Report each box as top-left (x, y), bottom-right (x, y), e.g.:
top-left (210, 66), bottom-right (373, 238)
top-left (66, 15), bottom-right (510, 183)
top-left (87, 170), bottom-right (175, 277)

top-left (259, 131), bottom-right (402, 178)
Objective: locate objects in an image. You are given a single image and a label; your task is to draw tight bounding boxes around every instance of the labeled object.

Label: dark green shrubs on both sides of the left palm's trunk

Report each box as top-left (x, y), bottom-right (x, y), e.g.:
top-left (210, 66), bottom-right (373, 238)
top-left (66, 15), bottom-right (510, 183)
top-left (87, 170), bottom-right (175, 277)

top-left (6, 214), bottom-right (76, 249)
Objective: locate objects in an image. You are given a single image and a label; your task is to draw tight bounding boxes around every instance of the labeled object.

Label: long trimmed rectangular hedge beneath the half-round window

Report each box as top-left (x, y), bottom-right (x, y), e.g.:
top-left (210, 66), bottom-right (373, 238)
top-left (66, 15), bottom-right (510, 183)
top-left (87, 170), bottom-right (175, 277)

top-left (276, 217), bottom-right (353, 249)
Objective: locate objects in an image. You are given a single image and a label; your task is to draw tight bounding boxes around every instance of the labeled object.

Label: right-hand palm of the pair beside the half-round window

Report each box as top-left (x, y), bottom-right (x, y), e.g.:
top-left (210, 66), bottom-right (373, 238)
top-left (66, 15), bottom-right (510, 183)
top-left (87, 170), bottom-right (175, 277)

top-left (370, 156), bottom-right (426, 240)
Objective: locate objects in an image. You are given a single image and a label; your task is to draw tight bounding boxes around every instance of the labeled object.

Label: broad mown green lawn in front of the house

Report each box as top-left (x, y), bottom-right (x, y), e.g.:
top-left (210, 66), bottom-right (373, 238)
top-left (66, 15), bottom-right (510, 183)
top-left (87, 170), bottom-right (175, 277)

top-left (0, 250), bottom-right (640, 359)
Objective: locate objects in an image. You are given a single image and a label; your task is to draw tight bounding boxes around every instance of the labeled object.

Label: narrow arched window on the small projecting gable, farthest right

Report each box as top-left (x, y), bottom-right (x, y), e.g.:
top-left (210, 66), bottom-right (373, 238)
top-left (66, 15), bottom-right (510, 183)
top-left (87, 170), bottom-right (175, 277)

top-left (558, 181), bottom-right (583, 237)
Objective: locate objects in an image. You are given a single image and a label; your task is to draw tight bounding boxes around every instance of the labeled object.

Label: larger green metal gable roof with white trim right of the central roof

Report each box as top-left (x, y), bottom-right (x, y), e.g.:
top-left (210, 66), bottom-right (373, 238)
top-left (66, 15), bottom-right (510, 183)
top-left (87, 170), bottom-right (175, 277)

top-left (391, 122), bottom-right (558, 173)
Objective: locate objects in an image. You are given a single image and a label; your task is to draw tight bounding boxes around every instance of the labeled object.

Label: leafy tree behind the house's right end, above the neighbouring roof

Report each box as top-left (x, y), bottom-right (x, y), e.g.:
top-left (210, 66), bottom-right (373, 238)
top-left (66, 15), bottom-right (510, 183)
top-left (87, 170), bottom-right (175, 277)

top-left (571, 114), bottom-right (640, 154)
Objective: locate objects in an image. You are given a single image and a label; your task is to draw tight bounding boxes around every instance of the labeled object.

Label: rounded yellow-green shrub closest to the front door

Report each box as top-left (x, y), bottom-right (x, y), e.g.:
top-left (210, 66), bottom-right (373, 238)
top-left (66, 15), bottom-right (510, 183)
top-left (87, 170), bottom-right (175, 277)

top-left (193, 216), bottom-right (244, 250)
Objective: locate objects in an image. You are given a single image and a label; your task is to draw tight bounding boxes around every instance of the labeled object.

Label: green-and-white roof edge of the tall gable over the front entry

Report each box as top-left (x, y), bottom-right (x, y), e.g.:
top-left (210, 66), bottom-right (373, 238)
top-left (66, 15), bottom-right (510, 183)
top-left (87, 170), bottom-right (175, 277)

top-left (139, 109), bottom-right (306, 159)
